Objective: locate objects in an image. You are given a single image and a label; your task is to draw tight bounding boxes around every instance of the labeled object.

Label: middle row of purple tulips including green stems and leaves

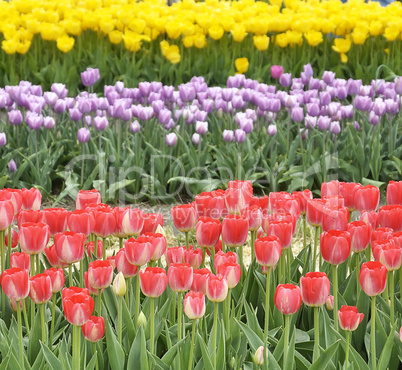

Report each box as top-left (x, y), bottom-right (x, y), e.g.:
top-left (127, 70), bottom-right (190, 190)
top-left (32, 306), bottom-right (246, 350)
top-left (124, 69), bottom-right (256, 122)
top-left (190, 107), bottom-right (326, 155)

top-left (0, 64), bottom-right (402, 201)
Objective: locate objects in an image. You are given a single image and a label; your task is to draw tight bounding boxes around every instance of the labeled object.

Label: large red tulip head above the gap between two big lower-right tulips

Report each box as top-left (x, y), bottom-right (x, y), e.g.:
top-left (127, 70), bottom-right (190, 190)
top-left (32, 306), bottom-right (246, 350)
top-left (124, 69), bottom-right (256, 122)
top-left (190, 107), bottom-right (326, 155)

top-left (320, 230), bottom-right (351, 265)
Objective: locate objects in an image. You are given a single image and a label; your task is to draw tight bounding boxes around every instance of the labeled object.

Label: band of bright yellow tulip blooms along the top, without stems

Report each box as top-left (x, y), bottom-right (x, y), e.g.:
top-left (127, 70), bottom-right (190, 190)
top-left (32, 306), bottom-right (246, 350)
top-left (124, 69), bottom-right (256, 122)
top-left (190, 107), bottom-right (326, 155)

top-left (0, 0), bottom-right (402, 63)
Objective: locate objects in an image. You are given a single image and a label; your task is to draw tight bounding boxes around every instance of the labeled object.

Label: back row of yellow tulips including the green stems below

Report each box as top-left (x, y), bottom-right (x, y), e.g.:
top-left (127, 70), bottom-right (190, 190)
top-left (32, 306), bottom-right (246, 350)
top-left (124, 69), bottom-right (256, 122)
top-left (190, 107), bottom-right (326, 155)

top-left (0, 0), bottom-right (401, 90)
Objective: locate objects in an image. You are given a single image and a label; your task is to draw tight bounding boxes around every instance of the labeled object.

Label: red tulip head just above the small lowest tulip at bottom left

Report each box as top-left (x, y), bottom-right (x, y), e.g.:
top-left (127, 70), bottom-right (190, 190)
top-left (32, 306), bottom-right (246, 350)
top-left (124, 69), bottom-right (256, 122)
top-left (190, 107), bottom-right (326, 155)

top-left (62, 288), bottom-right (94, 326)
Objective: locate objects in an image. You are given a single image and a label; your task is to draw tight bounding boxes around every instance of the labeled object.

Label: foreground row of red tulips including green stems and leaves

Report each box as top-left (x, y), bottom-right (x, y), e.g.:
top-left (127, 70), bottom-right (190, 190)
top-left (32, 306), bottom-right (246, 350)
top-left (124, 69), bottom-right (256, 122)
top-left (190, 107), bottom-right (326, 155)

top-left (0, 181), bottom-right (402, 369)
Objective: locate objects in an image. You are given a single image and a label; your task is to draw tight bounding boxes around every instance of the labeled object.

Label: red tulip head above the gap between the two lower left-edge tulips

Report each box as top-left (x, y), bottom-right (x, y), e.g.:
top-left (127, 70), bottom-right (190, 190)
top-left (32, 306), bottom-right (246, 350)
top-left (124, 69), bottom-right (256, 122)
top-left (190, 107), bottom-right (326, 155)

top-left (19, 222), bottom-right (50, 254)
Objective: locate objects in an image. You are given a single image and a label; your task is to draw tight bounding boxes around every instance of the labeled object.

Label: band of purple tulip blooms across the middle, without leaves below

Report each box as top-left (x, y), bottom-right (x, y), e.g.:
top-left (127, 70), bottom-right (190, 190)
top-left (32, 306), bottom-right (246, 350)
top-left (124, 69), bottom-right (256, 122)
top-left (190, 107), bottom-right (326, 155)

top-left (0, 64), bottom-right (402, 146)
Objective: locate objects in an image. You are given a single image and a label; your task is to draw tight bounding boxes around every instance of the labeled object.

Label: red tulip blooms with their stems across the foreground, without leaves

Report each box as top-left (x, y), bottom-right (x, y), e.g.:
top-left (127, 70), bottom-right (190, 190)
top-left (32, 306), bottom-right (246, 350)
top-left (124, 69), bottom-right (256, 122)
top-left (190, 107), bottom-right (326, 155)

top-left (0, 181), bottom-right (402, 366)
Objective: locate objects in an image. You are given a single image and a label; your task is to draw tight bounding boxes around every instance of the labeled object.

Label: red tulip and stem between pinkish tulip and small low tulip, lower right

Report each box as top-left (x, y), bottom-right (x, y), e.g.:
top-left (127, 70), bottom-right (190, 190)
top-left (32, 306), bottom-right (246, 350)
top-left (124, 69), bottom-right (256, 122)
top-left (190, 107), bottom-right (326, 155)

top-left (300, 272), bottom-right (331, 362)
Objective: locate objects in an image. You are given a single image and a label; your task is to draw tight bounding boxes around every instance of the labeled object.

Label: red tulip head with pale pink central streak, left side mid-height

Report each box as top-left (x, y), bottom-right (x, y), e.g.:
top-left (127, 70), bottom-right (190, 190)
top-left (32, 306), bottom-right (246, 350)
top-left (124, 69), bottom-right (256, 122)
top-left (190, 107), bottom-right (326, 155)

top-left (54, 231), bottom-right (85, 264)
